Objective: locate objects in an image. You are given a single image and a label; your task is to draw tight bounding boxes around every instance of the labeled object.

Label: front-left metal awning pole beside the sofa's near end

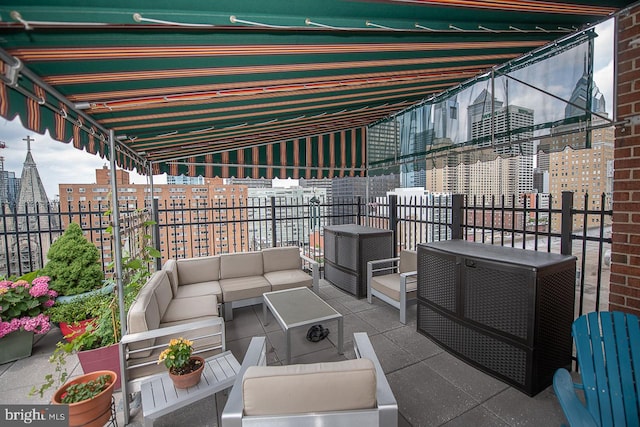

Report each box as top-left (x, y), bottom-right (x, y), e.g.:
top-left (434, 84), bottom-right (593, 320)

top-left (109, 129), bottom-right (129, 424)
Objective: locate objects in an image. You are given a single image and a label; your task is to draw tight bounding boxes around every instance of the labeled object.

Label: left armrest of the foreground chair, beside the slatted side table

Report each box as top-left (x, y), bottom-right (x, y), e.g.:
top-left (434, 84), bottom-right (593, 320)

top-left (222, 337), bottom-right (267, 427)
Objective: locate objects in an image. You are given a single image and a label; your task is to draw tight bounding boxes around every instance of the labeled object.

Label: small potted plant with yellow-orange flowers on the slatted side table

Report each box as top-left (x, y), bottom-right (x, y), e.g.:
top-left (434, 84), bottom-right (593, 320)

top-left (158, 337), bottom-right (204, 388)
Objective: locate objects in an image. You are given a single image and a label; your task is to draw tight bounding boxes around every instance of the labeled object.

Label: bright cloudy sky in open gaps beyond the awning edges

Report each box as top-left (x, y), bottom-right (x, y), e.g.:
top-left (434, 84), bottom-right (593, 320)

top-left (0, 19), bottom-right (614, 199)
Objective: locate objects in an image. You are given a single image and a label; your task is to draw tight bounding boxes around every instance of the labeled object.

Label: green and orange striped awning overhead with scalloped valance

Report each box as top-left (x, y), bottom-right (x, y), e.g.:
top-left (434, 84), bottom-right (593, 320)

top-left (0, 0), bottom-right (632, 178)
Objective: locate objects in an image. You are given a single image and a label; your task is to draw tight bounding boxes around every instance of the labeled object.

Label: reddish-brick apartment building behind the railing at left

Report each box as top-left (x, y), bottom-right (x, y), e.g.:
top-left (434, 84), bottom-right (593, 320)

top-left (59, 166), bottom-right (248, 262)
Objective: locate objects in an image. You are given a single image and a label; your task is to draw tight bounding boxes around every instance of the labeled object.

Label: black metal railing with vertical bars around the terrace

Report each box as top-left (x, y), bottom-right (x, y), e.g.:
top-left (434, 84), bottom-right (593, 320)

top-left (0, 193), bottom-right (612, 314)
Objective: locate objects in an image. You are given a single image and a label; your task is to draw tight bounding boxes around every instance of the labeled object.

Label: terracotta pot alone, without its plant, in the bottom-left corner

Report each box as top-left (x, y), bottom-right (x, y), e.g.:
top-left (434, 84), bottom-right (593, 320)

top-left (52, 371), bottom-right (118, 427)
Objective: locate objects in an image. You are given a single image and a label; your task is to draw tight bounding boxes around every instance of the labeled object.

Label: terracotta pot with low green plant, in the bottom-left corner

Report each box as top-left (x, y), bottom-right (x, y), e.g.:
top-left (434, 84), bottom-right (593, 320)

top-left (52, 371), bottom-right (118, 427)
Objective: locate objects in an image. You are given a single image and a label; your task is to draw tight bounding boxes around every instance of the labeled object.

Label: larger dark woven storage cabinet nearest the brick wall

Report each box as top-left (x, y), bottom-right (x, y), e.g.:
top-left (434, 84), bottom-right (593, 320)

top-left (417, 240), bottom-right (576, 396)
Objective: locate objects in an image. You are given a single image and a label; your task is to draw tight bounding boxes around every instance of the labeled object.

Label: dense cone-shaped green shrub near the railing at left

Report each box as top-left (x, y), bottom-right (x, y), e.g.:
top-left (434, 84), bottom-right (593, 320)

top-left (43, 223), bottom-right (104, 295)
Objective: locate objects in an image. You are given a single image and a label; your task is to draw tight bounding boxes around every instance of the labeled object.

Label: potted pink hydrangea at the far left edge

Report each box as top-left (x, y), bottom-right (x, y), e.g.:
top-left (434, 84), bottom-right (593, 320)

top-left (0, 273), bottom-right (57, 364)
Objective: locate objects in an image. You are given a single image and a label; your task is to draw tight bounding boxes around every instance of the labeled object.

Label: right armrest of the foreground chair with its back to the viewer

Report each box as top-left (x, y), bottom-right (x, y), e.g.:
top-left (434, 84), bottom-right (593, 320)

top-left (353, 332), bottom-right (398, 427)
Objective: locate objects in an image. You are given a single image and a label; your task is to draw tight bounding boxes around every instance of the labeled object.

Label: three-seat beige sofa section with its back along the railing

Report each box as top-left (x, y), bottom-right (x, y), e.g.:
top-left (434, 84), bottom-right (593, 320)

top-left (162, 246), bottom-right (320, 320)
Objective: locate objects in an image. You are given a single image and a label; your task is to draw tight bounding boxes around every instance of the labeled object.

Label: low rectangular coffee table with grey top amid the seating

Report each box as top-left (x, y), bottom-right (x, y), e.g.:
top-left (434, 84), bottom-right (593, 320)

top-left (262, 287), bottom-right (344, 365)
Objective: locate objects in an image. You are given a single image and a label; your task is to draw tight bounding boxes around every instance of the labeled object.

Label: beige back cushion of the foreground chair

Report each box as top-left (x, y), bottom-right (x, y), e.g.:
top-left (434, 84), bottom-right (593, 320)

top-left (242, 359), bottom-right (376, 415)
